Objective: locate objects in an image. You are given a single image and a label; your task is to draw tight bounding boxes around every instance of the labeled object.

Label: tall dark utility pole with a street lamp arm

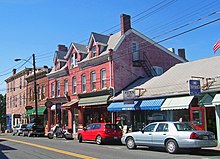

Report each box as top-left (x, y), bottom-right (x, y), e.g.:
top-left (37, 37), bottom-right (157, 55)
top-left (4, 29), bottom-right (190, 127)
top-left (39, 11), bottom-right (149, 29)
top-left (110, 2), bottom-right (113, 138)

top-left (15, 54), bottom-right (39, 122)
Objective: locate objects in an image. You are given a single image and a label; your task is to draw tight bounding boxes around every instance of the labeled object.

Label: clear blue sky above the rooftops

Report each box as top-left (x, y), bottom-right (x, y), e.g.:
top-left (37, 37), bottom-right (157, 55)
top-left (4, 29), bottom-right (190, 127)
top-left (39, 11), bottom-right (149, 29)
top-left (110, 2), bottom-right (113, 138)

top-left (0, 0), bottom-right (220, 94)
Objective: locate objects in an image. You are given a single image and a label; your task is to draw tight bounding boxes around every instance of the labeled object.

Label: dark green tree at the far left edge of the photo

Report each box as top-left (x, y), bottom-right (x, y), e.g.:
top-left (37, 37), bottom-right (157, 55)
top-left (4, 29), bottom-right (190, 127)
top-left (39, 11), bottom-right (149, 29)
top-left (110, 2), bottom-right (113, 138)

top-left (0, 94), bottom-right (6, 130)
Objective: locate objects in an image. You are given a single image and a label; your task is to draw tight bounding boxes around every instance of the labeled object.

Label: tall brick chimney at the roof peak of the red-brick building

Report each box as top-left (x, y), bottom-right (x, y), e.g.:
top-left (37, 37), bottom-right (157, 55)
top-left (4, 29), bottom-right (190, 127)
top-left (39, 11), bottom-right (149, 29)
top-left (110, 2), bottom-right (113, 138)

top-left (120, 14), bottom-right (131, 35)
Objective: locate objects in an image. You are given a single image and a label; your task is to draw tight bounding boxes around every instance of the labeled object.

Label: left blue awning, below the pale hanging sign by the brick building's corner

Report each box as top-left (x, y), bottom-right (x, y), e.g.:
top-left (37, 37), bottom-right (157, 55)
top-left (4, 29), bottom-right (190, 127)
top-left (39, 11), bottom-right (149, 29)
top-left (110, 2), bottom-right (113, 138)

top-left (107, 101), bottom-right (141, 111)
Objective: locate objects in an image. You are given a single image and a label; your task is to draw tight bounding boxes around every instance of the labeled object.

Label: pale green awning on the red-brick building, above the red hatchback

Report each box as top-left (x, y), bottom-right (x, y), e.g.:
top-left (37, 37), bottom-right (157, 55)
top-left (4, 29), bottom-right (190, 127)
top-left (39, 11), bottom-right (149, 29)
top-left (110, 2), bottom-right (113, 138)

top-left (78, 95), bottom-right (110, 106)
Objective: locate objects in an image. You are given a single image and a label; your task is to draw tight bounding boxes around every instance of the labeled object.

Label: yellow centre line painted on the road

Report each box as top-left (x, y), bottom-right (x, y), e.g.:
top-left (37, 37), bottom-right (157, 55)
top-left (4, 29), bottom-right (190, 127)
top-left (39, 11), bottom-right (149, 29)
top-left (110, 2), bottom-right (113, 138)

top-left (0, 138), bottom-right (97, 159)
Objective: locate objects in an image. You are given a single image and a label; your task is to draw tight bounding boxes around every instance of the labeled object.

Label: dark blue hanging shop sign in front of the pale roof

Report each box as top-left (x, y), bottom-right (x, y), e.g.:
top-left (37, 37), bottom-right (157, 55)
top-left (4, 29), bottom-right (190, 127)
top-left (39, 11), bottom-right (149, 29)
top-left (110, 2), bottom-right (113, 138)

top-left (189, 80), bottom-right (201, 96)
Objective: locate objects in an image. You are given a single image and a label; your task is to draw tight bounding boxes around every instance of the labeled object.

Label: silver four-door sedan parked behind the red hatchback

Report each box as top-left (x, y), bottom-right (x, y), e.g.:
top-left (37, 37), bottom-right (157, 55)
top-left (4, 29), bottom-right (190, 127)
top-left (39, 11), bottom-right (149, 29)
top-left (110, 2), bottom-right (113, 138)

top-left (121, 122), bottom-right (217, 153)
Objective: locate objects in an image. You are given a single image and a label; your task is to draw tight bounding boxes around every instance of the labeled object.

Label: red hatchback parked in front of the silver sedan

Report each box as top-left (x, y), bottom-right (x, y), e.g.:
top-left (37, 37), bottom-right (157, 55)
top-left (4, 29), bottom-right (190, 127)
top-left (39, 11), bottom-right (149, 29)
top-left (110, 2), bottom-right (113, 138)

top-left (78, 123), bottom-right (122, 145)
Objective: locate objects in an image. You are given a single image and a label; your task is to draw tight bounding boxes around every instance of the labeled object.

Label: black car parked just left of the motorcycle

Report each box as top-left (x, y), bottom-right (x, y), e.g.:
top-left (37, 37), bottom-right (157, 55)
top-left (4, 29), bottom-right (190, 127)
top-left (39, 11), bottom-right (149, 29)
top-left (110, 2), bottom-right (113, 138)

top-left (22, 123), bottom-right (45, 137)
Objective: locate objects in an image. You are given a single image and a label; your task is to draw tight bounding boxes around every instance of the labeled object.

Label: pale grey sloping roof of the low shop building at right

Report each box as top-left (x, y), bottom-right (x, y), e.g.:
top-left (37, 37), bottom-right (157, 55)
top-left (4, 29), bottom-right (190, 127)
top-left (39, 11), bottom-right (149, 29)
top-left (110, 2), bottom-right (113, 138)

top-left (117, 56), bottom-right (220, 98)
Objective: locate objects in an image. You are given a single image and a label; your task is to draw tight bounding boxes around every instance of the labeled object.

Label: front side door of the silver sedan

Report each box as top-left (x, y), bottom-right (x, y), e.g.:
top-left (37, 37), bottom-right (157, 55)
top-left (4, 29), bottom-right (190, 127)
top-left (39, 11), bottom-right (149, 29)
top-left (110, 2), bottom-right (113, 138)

top-left (136, 123), bottom-right (157, 146)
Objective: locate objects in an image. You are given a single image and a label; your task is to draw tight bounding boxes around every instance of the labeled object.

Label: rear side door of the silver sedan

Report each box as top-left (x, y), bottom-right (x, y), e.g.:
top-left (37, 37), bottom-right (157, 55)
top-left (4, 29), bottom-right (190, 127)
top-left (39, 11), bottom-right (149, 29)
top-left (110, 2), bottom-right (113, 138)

top-left (152, 123), bottom-right (169, 147)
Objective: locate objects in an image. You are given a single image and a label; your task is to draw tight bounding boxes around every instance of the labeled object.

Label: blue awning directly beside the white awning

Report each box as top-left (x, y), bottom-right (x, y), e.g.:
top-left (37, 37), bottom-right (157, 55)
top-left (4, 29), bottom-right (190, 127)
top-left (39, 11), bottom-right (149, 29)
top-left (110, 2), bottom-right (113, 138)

top-left (140, 99), bottom-right (165, 110)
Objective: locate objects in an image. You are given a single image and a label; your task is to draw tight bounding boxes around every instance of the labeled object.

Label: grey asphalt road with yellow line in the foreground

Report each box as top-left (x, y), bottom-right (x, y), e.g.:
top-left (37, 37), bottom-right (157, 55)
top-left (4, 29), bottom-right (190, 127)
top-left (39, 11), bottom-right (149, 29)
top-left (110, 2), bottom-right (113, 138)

top-left (0, 134), bottom-right (220, 159)
